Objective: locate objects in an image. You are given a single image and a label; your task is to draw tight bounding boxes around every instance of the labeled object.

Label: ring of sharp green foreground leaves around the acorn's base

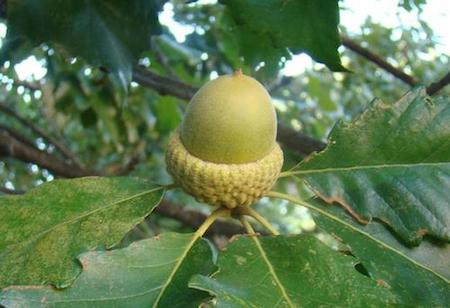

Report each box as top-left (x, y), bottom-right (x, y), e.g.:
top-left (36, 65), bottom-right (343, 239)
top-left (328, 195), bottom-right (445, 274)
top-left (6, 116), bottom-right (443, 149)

top-left (0, 90), bottom-right (450, 307)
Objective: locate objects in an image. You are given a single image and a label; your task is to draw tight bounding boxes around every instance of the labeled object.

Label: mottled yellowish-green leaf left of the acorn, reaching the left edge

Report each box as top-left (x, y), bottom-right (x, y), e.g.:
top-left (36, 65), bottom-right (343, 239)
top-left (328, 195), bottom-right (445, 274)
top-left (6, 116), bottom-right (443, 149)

top-left (0, 177), bottom-right (164, 289)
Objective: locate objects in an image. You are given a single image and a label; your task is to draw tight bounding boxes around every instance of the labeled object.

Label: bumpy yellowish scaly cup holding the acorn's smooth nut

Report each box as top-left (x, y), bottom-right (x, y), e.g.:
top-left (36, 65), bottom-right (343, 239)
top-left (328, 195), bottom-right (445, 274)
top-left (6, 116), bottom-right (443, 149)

top-left (166, 130), bottom-right (283, 208)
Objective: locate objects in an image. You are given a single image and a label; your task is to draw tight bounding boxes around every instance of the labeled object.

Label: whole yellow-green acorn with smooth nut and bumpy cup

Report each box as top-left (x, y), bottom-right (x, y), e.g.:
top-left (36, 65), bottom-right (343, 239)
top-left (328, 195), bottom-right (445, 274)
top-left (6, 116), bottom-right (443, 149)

top-left (166, 71), bottom-right (283, 208)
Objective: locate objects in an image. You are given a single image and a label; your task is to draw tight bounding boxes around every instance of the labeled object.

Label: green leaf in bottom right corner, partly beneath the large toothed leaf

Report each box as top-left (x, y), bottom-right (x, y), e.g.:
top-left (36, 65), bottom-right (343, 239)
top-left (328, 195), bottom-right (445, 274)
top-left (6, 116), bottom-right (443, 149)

top-left (270, 193), bottom-right (450, 307)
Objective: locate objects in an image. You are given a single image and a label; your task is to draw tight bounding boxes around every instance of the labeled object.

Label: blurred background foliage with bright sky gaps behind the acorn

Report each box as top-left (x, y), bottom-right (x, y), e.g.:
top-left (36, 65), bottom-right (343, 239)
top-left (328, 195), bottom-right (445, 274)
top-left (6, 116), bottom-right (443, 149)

top-left (0, 0), bottom-right (450, 237)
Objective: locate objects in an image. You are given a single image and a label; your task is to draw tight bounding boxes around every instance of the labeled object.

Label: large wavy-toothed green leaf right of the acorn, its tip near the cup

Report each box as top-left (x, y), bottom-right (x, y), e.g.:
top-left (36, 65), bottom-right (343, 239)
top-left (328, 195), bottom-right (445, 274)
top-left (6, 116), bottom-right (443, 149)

top-left (288, 89), bottom-right (450, 245)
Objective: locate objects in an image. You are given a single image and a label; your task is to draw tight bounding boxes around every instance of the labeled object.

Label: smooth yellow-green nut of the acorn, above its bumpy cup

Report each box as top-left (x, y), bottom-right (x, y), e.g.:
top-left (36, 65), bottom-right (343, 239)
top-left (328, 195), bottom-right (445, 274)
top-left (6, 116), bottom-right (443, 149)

top-left (180, 71), bottom-right (277, 164)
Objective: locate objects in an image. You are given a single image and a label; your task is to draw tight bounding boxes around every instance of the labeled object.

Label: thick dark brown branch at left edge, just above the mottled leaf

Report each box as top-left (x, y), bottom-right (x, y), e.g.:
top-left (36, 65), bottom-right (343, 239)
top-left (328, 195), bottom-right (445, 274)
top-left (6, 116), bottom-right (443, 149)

top-left (0, 126), bottom-right (92, 178)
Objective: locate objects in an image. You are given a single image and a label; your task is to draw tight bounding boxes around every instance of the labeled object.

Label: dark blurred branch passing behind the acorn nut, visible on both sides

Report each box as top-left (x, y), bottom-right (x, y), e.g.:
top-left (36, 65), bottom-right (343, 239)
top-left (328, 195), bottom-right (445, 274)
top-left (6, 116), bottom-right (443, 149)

top-left (133, 67), bottom-right (325, 156)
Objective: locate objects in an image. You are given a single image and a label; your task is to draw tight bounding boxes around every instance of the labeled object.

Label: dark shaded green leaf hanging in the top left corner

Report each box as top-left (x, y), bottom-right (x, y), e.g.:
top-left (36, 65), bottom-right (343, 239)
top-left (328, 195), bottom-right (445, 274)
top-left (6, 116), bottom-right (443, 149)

top-left (0, 0), bottom-right (162, 86)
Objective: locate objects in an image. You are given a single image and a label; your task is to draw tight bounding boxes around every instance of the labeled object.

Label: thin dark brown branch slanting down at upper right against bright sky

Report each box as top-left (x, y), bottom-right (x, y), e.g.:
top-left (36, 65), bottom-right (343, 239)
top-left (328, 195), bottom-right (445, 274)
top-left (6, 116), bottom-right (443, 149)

top-left (341, 37), bottom-right (418, 87)
